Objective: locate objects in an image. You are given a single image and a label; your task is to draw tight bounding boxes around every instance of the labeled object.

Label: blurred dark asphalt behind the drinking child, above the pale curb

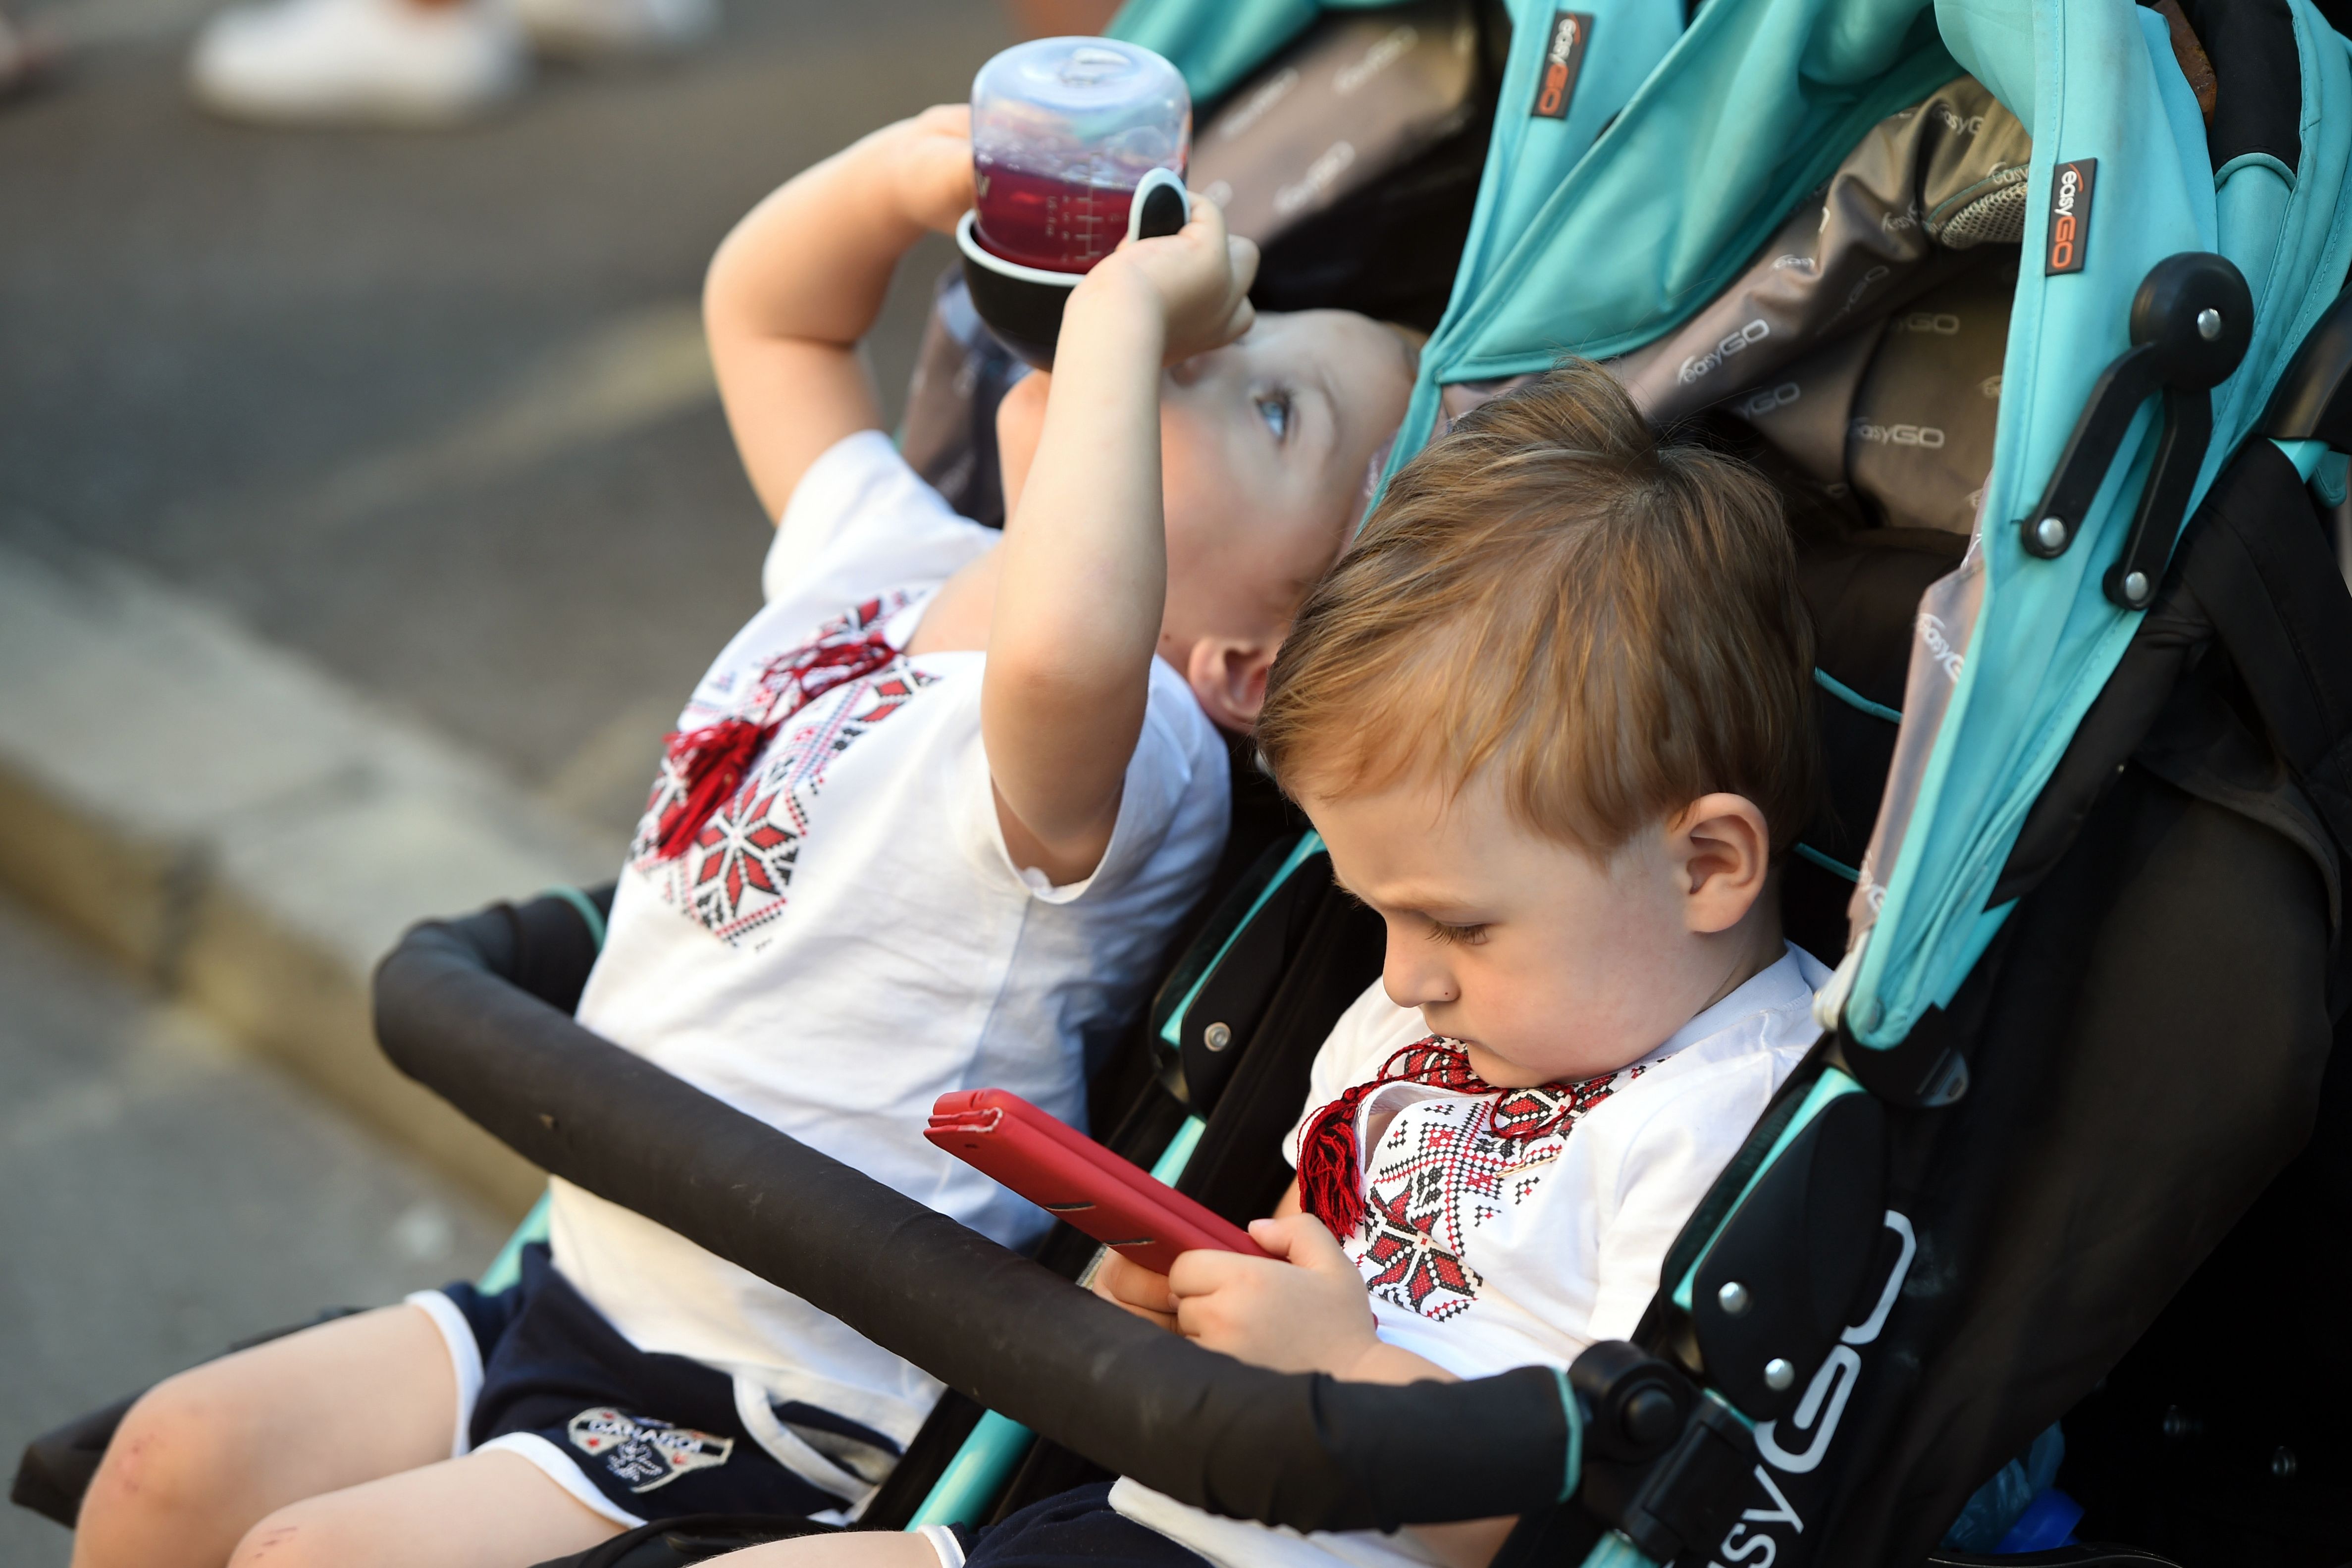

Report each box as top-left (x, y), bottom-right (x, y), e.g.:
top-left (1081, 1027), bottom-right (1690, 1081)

top-left (0, 0), bottom-right (1009, 856)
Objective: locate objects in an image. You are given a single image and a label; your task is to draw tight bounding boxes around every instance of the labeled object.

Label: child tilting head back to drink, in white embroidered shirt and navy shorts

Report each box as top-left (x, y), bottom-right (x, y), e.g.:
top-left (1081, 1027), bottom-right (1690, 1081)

top-left (75, 108), bottom-right (1413, 1568)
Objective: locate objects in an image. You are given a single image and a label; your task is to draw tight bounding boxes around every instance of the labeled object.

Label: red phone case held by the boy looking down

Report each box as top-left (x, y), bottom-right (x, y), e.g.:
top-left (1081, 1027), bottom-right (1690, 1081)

top-left (922, 1089), bottom-right (1265, 1274)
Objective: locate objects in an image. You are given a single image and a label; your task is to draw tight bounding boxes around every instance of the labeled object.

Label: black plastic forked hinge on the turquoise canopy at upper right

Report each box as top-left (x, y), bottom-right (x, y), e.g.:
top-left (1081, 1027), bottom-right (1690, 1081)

top-left (2018, 252), bottom-right (2253, 609)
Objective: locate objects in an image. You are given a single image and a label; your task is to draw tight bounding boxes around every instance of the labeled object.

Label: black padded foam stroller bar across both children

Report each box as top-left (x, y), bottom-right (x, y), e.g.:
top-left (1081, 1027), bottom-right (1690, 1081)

top-left (376, 917), bottom-right (1573, 1530)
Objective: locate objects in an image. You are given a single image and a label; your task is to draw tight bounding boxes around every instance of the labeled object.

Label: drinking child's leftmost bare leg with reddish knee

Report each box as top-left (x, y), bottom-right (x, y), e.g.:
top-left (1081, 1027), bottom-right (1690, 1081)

top-left (73, 1307), bottom-right (456, 1568)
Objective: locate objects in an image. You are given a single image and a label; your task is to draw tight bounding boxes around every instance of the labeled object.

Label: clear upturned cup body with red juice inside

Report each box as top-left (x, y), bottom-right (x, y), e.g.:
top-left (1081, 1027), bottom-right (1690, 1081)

top-left (971, 38), bottom-right (1193, 273)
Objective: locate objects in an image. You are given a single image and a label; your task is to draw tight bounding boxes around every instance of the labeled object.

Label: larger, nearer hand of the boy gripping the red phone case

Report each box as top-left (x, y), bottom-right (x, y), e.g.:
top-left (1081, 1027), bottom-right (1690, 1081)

top-left (1169, 1215), bottom-right (1381, 1378)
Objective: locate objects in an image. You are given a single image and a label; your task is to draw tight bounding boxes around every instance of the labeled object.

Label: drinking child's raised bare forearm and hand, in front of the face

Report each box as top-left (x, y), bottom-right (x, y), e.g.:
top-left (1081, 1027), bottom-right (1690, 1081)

top-left (981, 200), bottom-right (1258, 882)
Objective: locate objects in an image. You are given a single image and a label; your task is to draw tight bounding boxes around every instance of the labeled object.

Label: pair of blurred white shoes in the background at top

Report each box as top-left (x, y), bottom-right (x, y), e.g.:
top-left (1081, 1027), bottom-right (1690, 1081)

top-left (188, 0), bottom-right (717, 127)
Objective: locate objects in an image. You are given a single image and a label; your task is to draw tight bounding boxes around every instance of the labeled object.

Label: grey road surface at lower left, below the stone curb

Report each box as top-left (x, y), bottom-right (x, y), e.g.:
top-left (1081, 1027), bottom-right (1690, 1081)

top-left (0, 903), bottom-right (503, 1568)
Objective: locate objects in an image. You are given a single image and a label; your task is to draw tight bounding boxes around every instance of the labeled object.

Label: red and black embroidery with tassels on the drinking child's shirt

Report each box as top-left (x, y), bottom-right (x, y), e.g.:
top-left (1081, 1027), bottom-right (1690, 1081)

top-left (628, 592), bottom-right (936, 947)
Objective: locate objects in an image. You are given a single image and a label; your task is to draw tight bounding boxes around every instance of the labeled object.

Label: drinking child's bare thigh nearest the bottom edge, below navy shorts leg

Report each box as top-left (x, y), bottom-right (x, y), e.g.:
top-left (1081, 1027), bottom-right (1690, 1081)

top-left (228, 1448), bottom-right (621, 1568)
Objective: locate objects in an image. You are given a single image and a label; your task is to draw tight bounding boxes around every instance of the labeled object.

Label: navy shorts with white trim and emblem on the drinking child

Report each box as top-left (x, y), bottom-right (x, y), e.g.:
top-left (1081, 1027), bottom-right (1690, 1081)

top-left (409, 1246), bottom-right (898, 1526)
